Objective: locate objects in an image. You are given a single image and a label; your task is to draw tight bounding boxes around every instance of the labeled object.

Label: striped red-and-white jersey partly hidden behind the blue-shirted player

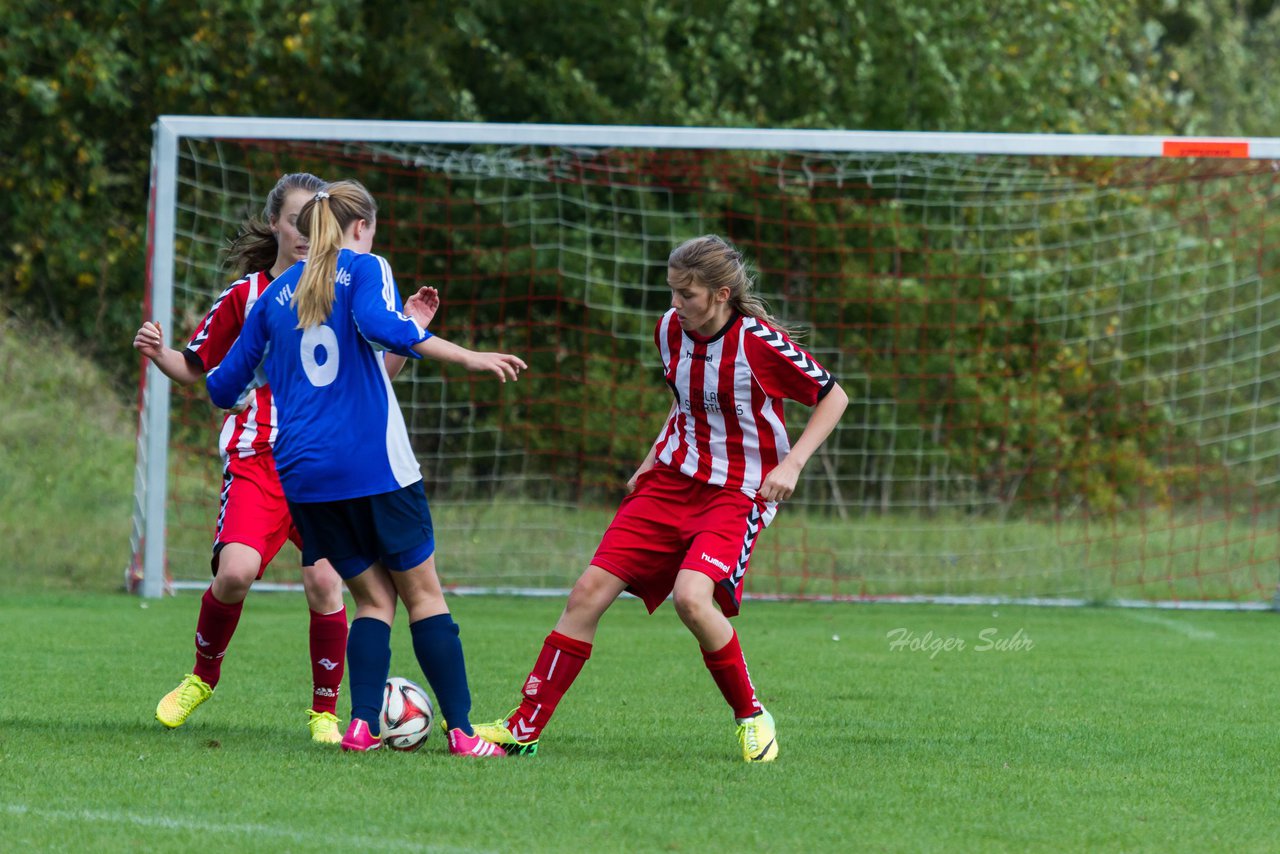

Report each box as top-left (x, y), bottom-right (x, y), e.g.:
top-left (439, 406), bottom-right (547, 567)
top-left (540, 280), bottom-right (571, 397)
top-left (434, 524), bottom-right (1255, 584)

top-left (184, 271), bottom-right (276, 457)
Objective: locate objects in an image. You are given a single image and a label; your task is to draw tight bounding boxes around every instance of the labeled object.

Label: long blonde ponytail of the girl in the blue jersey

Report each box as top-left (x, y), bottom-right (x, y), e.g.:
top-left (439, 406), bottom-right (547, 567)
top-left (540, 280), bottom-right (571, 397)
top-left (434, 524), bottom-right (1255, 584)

top-left (289, 181), bottom-right (378, 329)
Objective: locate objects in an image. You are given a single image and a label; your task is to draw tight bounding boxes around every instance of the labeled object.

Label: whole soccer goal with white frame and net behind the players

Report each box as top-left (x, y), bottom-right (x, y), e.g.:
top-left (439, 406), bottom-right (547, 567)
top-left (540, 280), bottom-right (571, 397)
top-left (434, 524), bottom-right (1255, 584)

top-left (129, 117), bottom-right (1280, 608)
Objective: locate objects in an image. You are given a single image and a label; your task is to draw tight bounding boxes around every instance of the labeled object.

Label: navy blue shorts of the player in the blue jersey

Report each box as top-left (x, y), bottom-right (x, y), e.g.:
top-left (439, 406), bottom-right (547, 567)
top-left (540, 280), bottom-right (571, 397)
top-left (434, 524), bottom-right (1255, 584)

top-left (289, 481), bottom-right (435, 579)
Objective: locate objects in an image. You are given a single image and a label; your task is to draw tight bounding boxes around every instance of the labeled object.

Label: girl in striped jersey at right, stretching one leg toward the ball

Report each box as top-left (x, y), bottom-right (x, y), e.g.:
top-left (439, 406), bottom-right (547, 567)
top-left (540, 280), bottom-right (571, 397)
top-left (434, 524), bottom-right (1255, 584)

top-left (476, 236), bottom-right (849, 762)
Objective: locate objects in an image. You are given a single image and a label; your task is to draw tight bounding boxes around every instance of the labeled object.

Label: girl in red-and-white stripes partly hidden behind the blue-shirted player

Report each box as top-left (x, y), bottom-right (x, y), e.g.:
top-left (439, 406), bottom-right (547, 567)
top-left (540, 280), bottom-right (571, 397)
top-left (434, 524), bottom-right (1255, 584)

top-left (133, 173), bottom-right (439, 745)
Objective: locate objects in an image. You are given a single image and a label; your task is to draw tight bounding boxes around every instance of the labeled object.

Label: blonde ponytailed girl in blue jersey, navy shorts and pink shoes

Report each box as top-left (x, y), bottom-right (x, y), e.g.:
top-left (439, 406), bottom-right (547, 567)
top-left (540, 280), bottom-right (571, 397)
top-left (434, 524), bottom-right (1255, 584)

top-left (206, 181), bottom-right (526, 757)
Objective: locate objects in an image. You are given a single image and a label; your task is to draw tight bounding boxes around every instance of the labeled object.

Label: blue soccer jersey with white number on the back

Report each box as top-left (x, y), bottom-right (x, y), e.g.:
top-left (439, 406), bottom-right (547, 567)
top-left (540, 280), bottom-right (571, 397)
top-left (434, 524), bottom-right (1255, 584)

top-left (206, 250), bottom-right (431, 502)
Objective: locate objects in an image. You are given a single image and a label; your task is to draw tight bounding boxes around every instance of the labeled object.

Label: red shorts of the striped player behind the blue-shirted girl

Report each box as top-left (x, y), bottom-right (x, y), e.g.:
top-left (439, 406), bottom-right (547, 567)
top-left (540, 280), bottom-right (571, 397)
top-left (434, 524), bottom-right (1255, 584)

top-left (210, 453), bottom-right (302, 577)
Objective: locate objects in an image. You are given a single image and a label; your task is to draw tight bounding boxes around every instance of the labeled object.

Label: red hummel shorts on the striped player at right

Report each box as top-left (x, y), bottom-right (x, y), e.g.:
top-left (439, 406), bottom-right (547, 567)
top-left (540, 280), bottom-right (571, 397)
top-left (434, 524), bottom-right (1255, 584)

top-left (591, 465), bottom-right (764, 617)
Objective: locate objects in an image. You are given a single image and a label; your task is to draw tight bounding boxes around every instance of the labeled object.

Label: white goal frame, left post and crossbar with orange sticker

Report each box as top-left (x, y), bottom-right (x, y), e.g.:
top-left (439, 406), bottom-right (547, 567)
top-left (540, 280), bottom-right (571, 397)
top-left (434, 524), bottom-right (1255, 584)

top-left (133, 115), bottom-right (1280, 608)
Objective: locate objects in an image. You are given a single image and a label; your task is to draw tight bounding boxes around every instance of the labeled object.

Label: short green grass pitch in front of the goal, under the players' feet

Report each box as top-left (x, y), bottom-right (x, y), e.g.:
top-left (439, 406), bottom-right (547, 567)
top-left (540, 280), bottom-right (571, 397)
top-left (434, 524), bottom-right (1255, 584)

top-left (0, 593), bottom-right (1280, 851)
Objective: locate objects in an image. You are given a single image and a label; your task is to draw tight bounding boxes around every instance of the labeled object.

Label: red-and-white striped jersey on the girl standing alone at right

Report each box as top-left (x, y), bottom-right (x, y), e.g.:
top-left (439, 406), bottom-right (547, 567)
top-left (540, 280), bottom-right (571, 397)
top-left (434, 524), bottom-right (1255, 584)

top-left (654, 309), bottom-right (836, 525)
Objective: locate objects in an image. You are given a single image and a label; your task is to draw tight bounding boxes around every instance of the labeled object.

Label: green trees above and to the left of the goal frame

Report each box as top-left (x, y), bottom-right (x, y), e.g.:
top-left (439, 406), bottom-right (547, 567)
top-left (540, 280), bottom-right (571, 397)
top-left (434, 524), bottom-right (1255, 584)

top-left (10, 0), bottom-right (1280, 378)
